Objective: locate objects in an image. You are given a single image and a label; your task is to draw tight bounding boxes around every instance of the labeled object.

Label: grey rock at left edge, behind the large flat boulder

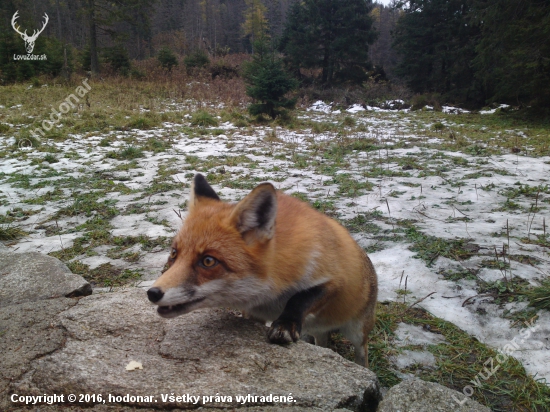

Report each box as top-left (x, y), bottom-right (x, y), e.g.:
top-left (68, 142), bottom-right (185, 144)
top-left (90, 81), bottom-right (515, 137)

top-left (0, 249), bottom-right (92, 307)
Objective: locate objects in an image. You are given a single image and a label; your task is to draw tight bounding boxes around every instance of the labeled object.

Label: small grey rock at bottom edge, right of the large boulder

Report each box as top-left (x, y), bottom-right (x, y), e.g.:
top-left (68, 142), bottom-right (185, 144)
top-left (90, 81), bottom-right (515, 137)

top-left (378, 379), bottom-right (491, 412)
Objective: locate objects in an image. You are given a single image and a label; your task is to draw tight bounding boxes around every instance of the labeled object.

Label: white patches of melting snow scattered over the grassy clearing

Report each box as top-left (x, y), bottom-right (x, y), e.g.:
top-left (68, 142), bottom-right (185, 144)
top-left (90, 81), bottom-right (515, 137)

top-left (0, 101), bottom-right (550, 380)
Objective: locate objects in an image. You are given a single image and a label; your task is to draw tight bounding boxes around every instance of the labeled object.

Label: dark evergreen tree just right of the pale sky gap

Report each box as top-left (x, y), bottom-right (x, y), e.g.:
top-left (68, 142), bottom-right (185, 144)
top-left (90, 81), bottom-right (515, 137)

top-left (394, 0), bottom-right (480, 101)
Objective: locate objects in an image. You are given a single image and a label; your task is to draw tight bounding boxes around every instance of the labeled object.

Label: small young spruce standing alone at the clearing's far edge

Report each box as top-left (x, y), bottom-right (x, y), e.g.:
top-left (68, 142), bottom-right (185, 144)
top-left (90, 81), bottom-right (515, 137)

top-left (243, 35), bottom-right (298, 119)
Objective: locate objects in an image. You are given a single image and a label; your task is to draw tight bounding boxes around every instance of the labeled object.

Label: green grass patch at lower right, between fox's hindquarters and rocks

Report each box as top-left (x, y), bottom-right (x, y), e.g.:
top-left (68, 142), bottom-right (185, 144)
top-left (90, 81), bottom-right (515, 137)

top-left (331, 302), bottom-right (550, 412)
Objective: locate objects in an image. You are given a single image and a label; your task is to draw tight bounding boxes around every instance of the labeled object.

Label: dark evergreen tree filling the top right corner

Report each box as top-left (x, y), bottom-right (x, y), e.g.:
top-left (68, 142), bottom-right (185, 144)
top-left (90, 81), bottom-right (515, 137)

top-left (472, 0), bottom-right (550, 107)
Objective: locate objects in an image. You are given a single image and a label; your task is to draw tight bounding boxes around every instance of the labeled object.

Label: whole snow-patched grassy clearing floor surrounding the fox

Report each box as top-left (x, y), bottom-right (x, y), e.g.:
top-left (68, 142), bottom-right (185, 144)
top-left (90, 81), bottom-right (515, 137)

top-left (0, 82), bottom-right (550, 411)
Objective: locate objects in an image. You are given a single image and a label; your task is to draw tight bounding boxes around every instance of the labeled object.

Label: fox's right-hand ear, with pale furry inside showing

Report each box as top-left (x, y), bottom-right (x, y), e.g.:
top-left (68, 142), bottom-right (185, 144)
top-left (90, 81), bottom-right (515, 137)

top-left (230, 183), bottom-right (277, 241)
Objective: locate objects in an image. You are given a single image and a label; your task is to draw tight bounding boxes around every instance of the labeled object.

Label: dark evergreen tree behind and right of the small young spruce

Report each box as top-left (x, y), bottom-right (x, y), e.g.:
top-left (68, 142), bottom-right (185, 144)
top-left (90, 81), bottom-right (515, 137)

top-left (279, 0), bottom-right (376, 84)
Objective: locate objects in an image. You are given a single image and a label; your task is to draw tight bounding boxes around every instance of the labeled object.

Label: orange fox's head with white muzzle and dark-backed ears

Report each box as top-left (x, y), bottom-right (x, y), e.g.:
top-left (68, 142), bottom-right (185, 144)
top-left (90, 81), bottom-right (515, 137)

top-left (147, 174), bottom-right (277, 318)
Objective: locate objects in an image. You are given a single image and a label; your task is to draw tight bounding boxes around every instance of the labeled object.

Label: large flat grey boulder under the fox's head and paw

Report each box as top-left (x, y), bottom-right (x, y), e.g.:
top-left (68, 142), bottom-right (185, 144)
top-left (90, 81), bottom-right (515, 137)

top-left (10, 289), bottom-right (379, 411)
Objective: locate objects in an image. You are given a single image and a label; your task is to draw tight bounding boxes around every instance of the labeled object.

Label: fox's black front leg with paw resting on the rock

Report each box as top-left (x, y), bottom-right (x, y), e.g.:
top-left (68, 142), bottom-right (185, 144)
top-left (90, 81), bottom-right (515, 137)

top-left (267, 285), bottom-right (325, 343)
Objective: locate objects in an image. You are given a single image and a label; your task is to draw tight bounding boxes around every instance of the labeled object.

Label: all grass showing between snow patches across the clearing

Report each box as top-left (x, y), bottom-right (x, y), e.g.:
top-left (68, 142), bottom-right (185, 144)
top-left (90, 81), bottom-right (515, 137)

top-left (0, 79), bottom-right (550, 411)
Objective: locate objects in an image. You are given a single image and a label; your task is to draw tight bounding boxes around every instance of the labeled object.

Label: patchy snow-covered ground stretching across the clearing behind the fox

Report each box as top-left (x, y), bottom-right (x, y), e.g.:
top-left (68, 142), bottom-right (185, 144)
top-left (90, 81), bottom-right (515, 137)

top-left (0, 101), bottom-right (550, 381)
